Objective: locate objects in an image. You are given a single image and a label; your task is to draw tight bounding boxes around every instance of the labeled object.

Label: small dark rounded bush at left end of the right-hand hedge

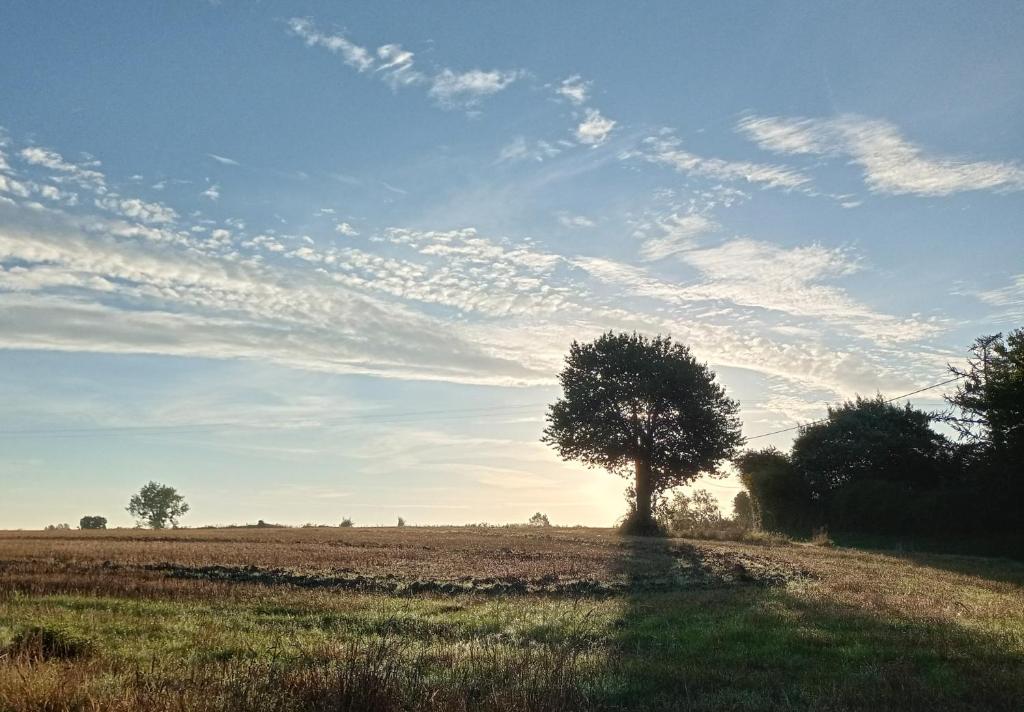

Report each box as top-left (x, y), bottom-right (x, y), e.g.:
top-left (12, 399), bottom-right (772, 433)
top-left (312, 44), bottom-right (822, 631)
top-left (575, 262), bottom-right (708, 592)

top-left (733, 448), bottom-right (814, 534)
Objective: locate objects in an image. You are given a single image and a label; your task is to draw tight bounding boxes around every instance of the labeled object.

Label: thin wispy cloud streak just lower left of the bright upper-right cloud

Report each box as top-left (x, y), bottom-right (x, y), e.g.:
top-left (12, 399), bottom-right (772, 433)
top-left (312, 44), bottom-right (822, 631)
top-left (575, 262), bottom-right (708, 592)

top-left (625, 132), bottom-right (811, 191)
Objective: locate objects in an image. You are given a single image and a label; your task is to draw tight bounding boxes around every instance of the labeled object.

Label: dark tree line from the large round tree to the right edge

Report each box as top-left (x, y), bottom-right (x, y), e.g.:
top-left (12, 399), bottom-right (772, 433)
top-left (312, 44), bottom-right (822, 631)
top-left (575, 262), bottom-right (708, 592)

top-left (543, 329), bottom-right (1024, 536)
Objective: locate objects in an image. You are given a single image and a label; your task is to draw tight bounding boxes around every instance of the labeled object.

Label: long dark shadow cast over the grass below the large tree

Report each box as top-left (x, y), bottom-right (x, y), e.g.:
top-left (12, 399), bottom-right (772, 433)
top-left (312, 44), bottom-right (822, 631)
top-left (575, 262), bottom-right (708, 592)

top-left (596, 539), bottom-right (1024, 711)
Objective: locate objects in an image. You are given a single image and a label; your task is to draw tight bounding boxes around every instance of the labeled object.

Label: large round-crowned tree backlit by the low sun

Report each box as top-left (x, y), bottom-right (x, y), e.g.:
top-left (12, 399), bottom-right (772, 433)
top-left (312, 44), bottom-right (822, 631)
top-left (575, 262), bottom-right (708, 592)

top-left (543, 332), bottom-right (743, 534)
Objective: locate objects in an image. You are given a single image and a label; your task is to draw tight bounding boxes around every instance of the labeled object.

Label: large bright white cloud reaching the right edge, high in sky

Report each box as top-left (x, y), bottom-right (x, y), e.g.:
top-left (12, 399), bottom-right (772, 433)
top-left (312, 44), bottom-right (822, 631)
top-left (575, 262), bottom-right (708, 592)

top-left (736, 114), bottom-right (1024, 196)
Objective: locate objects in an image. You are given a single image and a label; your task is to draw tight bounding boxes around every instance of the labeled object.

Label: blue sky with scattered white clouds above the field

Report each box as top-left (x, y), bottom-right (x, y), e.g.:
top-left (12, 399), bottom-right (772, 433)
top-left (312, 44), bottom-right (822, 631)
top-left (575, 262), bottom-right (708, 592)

top-left (0, 0), bottom-right (1024, 529)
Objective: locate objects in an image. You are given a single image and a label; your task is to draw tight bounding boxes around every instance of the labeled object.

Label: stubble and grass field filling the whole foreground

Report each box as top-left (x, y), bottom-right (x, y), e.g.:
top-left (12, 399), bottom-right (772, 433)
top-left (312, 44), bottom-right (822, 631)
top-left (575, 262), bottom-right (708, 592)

top-left (0, 528), bottom-right (1024, 712)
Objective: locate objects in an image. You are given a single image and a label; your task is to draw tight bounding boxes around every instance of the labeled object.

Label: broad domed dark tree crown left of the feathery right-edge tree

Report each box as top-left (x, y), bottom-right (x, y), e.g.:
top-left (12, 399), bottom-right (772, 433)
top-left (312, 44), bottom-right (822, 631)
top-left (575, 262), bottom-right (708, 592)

top-left (792, 395), bottom-right (946, 499)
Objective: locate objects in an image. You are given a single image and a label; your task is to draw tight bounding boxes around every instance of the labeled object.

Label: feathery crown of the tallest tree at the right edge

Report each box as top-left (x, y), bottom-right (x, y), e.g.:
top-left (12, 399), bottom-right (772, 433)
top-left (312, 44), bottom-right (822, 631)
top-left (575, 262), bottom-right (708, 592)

top-left (940, 329), bottom-right (1024, 462)
